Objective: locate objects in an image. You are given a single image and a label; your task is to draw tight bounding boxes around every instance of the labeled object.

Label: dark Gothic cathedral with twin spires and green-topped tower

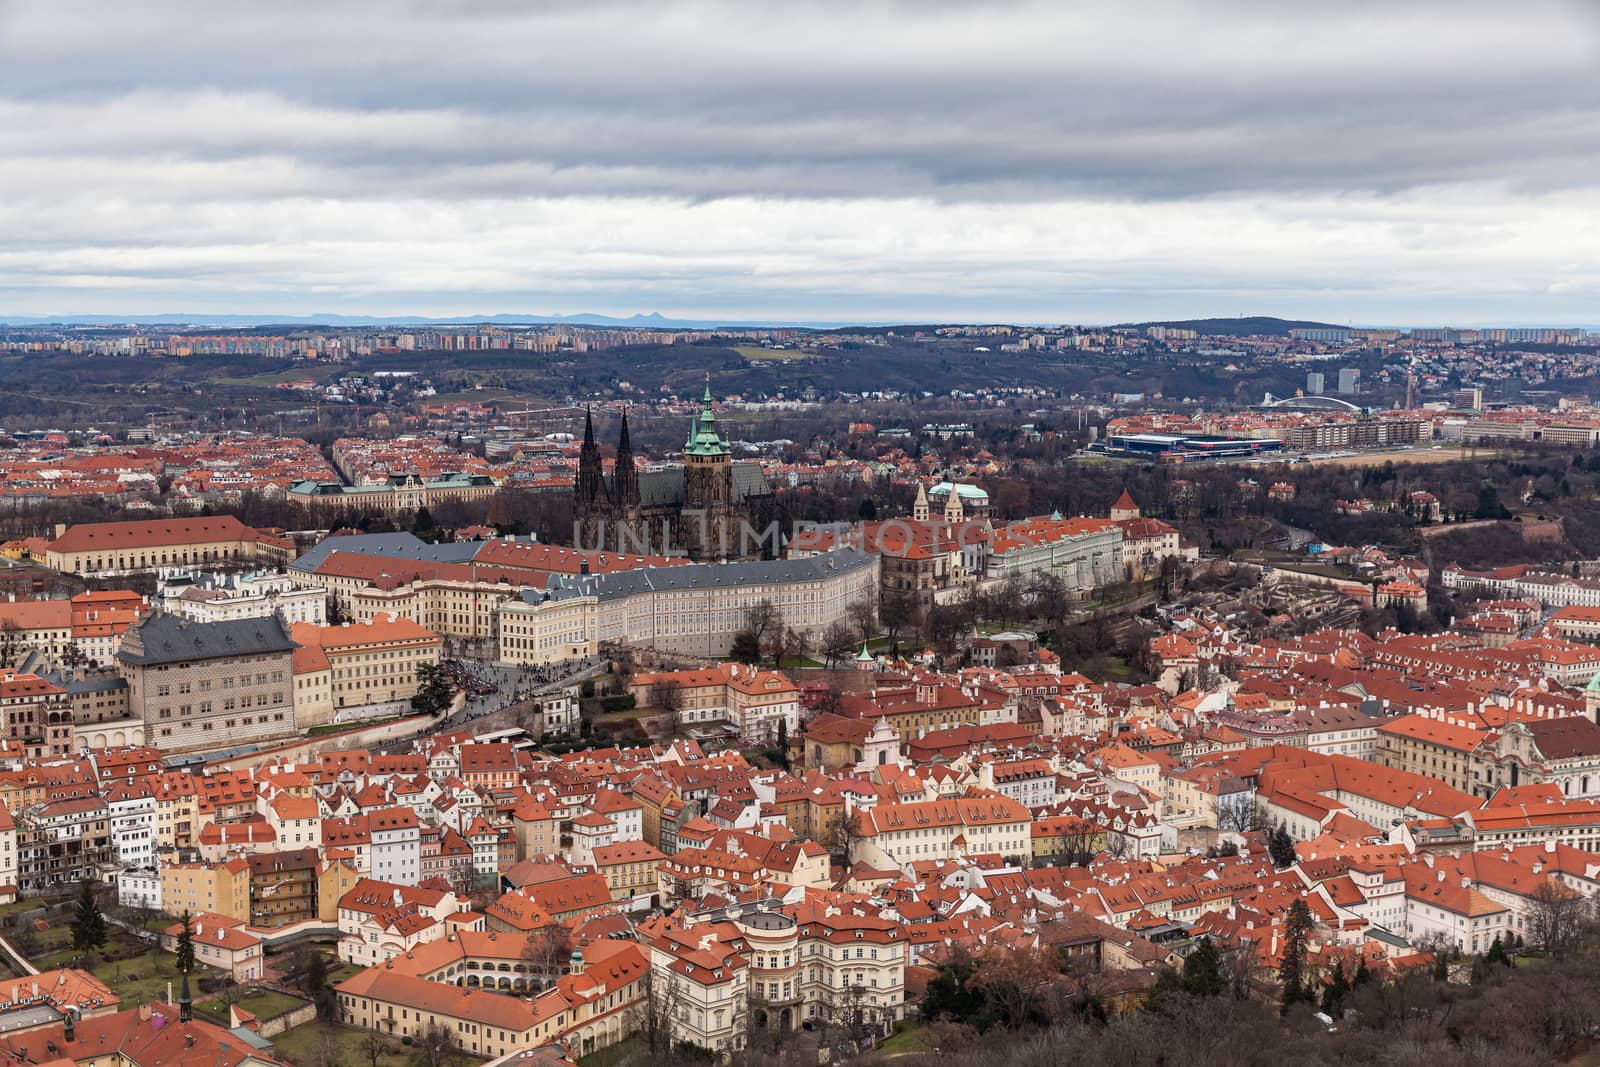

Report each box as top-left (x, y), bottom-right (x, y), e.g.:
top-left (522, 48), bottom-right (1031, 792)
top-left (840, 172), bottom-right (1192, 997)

top-left (573, 382), bottom-right (779, 560)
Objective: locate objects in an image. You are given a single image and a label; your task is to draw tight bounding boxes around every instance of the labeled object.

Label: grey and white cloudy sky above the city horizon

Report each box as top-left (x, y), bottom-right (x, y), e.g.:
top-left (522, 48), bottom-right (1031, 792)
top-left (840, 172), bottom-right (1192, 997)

top-left (0, 0), bottom-right (1600, 325)
